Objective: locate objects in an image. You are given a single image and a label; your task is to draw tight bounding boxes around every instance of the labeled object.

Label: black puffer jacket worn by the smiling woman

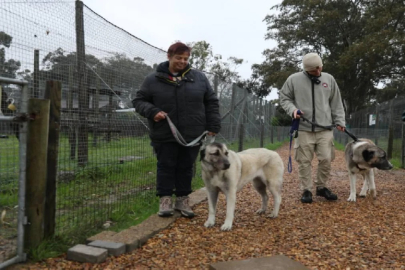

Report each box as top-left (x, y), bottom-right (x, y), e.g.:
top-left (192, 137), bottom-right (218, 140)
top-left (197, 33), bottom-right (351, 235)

top-left (132, 61), bottom-right (221, 142)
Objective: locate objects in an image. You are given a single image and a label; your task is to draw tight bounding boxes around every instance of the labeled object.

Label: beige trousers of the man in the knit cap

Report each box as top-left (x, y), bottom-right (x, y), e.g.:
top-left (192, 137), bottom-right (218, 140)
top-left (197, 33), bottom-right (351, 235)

top-left (294, 130), bottom-right (335, 191)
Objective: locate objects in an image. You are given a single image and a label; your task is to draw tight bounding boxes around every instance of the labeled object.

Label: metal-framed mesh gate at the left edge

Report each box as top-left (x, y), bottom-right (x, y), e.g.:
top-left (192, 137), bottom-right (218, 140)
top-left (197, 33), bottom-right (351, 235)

top-left (0, 77), bottom-right (30, 269)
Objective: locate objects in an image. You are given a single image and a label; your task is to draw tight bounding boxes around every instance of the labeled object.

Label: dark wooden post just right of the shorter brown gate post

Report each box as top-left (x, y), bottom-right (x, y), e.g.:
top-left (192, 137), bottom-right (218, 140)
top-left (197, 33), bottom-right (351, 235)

top-left (44, 81), bottom-right (62, 237)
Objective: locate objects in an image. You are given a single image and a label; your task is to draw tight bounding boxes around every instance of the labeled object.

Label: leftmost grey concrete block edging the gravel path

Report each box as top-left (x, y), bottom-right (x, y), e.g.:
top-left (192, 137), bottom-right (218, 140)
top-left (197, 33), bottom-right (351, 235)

top-left (66, 245), bottom-right (108, 263)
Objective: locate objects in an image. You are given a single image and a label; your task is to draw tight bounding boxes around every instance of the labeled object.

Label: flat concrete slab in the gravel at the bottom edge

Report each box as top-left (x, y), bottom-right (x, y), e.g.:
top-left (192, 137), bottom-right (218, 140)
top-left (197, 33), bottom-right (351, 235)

top-left (209, 255), bottom-right (309, 270)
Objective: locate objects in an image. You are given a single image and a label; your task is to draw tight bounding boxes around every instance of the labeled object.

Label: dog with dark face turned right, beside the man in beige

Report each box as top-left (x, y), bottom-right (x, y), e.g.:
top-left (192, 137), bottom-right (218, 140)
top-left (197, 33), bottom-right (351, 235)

top-left (345, 139), bottom-right (393, 202)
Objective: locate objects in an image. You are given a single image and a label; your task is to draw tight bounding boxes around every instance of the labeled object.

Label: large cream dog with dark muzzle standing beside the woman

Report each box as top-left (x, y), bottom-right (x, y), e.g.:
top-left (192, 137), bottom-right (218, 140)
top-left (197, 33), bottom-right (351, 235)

top-left (200, 143), bottom-right (284, 231)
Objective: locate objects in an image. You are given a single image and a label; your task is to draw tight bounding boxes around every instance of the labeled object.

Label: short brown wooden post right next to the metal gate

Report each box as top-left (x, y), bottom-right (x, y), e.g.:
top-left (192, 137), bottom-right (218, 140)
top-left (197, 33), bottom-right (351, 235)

top-left (24, 99), bottom-right (49, 250)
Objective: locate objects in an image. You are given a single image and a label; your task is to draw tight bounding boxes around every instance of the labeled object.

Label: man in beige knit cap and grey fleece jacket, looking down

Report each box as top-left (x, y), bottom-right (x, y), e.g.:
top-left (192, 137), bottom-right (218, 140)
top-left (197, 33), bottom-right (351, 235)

top-left (280, 53), bottom-right (345, 203)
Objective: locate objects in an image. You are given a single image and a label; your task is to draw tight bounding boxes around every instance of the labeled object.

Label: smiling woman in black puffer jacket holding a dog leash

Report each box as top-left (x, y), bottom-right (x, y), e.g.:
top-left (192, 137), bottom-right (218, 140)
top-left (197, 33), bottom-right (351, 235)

top-left (132, 42), bottom-right (221, 218)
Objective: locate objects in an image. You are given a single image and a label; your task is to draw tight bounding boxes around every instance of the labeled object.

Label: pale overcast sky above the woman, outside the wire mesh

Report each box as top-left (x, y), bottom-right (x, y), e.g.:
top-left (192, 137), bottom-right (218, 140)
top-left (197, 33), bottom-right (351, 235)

top-left (83, 0), bottom-right (281, 98)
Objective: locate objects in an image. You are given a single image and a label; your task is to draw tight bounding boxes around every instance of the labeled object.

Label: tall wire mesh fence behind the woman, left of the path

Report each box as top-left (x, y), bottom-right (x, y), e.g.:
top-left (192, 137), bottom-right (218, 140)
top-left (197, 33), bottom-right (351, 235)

top-left (0, 0), bottom-right (289, 262)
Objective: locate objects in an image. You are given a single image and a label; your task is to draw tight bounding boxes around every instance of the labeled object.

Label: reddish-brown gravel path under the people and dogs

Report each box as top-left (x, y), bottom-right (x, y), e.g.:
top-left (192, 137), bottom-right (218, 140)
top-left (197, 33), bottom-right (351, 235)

top-left (7, 144), bottom-right (405, 269)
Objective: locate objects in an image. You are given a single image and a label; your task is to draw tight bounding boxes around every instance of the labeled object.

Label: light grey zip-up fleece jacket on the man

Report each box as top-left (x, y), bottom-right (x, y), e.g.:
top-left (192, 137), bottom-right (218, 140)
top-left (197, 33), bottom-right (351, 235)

top-left (280, 72), bottom-right (346, 132)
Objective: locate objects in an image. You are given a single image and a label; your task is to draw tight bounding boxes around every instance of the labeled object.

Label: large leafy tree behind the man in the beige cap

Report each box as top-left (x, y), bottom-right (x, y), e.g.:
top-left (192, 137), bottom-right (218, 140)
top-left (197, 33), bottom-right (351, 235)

top-left (258, 0), bottom-right (405, 113)
